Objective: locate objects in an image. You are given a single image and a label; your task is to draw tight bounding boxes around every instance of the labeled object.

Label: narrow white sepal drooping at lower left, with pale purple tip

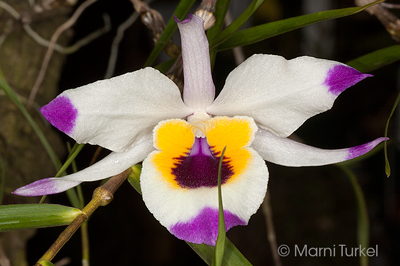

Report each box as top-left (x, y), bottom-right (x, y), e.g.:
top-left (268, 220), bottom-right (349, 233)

top-left (13, 135), bottom-right (154, 196)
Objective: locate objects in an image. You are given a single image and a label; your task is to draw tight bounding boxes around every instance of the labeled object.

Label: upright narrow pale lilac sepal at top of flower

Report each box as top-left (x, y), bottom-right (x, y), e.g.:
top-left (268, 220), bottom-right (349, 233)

top-left (177, 15), bottom-right (215, 110)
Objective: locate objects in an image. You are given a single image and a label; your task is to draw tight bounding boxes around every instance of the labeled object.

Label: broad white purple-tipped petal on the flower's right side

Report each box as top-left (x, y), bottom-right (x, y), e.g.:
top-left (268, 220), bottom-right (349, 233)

top-left (207, 55), bottom-right (370, 137)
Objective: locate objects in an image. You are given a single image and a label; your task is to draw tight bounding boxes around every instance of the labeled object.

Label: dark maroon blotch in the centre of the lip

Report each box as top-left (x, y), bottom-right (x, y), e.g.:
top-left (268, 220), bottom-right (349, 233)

top-left (171, 138), bottom-right (233, 188)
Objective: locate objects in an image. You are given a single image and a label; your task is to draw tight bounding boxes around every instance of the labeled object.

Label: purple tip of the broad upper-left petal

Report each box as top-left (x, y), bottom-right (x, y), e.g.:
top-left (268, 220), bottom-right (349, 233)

top-left (40, 96), bottom-right (78, 135)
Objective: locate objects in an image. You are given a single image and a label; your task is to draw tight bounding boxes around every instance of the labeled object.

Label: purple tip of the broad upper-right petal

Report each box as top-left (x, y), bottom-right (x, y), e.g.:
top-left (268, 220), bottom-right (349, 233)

top-left (324, 65), bottom-right (372, 96)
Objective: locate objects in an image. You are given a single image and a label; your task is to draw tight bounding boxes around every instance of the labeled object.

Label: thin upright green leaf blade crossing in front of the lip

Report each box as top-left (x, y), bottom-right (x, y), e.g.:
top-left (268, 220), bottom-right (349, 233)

top-left (212, 147), bottom-right (226, 266)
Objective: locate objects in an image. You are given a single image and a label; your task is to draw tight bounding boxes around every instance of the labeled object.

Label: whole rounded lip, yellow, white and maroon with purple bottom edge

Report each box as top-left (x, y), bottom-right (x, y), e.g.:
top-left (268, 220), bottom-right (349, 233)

top-left (140, 117), bottom-right (268, 245)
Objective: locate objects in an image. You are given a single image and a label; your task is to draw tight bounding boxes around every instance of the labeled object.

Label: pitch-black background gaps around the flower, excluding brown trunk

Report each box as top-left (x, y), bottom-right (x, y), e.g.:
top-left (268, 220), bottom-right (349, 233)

top-left (28, 0), bottom-right (400, 266)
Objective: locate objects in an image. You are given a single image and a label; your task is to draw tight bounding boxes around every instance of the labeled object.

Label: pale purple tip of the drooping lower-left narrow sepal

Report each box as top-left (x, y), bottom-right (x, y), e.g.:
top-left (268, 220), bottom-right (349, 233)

top-left (12, 178), bottom-right (60, 197)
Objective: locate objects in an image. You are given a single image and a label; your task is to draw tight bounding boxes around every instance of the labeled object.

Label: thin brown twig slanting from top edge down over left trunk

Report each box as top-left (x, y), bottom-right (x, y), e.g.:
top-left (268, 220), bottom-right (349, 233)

top-left (27, 0), bottom-right (97, 108)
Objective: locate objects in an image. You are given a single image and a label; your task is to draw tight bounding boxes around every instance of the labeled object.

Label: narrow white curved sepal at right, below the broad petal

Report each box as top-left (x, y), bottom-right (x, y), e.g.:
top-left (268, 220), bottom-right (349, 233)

top-left (252, 130), bottom-right (387, 166)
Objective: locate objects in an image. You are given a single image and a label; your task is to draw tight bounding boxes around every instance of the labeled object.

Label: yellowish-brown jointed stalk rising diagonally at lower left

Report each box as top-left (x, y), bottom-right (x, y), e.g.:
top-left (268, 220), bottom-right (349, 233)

top-left (35, 169), bottom-right (131, 266)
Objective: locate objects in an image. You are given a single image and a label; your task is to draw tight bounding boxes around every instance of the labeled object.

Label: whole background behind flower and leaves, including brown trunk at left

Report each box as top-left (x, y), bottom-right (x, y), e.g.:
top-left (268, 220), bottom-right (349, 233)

top-left (0, 0), bottom-right (400, 265)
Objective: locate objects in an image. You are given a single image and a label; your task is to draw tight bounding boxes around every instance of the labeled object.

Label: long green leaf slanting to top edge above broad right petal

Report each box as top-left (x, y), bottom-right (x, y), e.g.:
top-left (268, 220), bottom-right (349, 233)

top-left (218, 0), bottom-right (383, 50)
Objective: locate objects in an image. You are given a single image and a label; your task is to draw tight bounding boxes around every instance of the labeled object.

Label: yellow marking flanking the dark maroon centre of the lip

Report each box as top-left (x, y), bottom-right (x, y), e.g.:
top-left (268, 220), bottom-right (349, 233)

top-left (150, 117), bottom-right (256, 189)
